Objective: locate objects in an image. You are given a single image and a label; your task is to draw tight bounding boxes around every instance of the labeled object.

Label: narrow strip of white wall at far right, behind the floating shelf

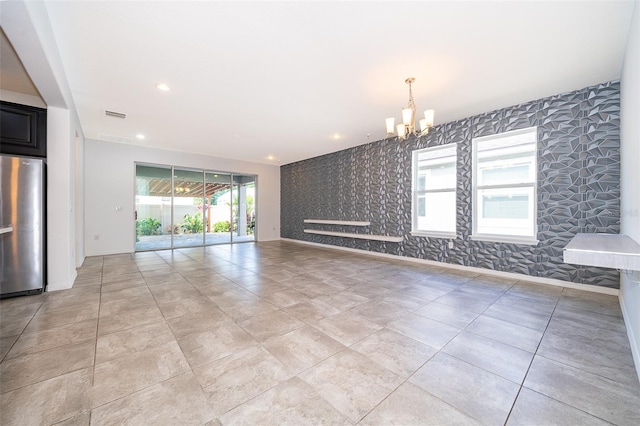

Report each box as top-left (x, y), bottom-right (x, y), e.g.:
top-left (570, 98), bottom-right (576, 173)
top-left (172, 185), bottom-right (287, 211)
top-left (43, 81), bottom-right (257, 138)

top-left (620, 2), bottom-right (640, 378)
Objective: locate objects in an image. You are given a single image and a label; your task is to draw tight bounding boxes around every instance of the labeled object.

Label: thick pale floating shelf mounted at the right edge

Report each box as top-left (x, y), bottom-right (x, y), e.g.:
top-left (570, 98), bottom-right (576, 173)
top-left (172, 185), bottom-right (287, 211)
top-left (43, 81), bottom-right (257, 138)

top-left (564, 234), bottom-right (640, 271)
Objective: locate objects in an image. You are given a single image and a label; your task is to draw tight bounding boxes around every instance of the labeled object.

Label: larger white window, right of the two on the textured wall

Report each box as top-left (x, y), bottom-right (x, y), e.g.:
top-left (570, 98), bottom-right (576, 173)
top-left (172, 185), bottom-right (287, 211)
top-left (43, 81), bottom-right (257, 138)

top-left (473, 127), bottom-right (537, 244)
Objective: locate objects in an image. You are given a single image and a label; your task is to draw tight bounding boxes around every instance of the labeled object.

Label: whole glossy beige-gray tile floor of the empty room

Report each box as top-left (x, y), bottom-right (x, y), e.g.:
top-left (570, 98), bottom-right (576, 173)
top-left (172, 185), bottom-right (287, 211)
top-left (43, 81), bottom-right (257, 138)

top-left (0, 241), bottom-right (640, 426)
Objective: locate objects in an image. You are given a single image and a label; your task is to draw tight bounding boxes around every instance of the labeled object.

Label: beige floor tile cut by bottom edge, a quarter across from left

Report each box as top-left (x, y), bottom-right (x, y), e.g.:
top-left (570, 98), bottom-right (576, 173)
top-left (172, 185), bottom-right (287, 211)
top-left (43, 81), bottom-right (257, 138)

top-left (91, 371), bottom-right (215, 426)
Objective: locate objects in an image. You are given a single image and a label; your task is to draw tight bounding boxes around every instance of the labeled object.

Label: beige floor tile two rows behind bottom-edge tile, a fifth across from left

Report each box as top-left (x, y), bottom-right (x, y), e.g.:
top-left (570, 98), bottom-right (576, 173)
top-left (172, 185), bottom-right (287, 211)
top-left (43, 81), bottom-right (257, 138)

top-left (95, 321), bottom-right (175, 364)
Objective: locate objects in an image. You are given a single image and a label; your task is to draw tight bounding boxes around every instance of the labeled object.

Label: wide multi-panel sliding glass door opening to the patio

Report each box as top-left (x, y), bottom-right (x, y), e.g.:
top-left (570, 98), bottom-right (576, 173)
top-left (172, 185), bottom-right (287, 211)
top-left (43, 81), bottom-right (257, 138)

top-left (135, 164), bottom-right (256, 251)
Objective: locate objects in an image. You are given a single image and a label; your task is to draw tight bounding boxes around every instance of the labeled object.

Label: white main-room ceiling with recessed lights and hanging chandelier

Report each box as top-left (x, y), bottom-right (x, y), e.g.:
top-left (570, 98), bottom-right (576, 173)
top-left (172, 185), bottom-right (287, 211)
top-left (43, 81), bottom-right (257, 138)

top-left (3, 0), bottom-right (634, 165)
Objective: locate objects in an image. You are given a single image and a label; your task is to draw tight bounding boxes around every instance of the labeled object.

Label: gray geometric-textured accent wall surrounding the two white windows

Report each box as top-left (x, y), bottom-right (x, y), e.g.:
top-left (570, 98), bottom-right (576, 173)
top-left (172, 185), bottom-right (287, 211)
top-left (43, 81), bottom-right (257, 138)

top-left (280, 81), bottom-right (620, 288)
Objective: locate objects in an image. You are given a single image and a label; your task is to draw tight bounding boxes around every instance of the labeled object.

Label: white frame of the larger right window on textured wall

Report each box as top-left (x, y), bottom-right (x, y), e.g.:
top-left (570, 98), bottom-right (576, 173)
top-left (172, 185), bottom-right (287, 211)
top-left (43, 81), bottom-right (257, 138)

top-left (470, 126), bottom-right (539, 245)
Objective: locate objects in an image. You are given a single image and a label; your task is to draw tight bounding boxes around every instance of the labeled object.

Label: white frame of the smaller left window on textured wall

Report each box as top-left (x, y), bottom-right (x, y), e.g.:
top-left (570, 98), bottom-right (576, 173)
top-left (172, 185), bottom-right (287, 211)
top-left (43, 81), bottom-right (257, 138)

top-left (411, 143), bottom-right (458, 239)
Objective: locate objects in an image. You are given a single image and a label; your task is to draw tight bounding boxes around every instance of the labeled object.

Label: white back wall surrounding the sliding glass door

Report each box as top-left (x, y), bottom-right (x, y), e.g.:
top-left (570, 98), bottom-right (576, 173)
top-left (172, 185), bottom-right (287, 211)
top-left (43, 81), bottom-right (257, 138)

top-left (85, 139), bottom-right (280, 256)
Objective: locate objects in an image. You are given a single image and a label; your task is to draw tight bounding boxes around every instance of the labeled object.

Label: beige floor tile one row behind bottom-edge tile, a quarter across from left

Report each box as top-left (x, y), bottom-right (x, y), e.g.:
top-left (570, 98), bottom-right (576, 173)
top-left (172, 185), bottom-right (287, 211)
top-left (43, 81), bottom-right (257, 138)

top-left (92, 342), bottom-right (189, 407)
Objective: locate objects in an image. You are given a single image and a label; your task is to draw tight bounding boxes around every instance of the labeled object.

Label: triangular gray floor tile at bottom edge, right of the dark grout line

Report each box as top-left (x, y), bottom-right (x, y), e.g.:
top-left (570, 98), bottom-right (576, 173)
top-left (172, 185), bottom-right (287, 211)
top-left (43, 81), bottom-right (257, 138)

top-left (507, 388), bottom-right (611, 426)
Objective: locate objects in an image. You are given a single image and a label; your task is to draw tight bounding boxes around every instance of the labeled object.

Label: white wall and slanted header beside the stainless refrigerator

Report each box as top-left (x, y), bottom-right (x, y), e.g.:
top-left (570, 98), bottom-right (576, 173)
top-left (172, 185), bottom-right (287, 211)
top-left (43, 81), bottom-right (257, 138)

top-left (0, 1), bottom-right (84, 291)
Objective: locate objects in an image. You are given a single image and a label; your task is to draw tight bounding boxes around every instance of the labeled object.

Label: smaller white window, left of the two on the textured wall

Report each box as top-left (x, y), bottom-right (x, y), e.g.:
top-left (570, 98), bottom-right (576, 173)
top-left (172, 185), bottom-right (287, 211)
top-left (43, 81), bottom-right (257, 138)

top-left (412, 144), bottom-right (457, 237)
